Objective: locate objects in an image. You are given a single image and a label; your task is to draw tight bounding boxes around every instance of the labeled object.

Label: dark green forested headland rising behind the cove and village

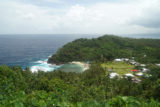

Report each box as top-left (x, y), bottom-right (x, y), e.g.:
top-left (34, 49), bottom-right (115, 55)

top-left (48, 35), bottom-right (160, 64)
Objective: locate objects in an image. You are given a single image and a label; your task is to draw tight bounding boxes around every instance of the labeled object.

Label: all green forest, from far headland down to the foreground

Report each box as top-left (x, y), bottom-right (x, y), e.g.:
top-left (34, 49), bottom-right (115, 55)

top-left (0, 36), bottom-right (160, 107)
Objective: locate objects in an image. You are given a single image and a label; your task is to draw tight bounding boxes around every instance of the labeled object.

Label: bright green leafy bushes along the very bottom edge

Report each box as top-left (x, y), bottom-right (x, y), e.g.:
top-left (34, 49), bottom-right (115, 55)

top-left (0, 91), bottom-right (160, 107)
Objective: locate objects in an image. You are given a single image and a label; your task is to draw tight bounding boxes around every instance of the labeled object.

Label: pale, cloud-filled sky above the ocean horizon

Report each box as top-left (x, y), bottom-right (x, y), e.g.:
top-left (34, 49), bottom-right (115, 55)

top-left (0, 0), bottom-right (160, 34)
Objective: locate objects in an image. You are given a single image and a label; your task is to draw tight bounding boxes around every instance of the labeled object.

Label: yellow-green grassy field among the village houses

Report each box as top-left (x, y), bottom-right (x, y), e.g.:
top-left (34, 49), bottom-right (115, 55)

top-left (102, 62), bottom-right (134, 76)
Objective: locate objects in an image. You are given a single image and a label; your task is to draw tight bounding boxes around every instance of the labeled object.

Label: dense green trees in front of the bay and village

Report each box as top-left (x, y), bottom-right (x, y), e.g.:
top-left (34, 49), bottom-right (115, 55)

top-left (0, 62), bottom-right (160, 107)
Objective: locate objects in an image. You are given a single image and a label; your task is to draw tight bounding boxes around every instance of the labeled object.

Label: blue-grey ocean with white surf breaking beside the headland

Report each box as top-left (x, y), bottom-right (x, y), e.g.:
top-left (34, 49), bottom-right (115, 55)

top-left (0, 34), bottom-right (160, 72)
